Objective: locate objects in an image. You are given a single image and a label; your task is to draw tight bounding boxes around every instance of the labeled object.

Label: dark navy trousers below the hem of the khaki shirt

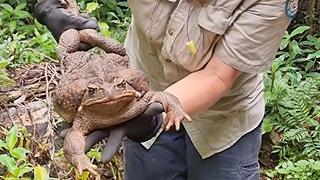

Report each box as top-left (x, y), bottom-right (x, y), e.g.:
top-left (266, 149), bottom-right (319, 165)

top-left (123, 126), bottom-right (261, 180)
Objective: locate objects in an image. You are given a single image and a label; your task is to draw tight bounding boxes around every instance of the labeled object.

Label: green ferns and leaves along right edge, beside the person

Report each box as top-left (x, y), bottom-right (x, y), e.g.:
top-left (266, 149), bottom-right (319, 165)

top-left (263, 26), bottom-right (320, 179)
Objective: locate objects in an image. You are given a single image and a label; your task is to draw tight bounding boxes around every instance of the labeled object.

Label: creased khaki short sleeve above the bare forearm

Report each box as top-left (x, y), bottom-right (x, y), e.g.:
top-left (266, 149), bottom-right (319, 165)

top-left (214, 0), bottom-right (290, 73)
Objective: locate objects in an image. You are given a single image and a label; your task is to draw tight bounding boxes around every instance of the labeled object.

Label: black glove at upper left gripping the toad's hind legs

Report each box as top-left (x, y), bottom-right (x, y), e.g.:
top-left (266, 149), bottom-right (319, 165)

top-left (33, 0), bottom-right (98, 42)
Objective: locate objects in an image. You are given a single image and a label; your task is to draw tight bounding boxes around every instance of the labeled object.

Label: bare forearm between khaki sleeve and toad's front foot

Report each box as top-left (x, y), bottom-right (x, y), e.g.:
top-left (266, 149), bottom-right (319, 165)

top-left (166, 57), bottom-right (240, 114)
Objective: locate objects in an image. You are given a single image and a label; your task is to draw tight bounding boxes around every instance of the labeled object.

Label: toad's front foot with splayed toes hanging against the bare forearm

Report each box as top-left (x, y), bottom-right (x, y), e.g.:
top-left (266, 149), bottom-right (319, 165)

top-left (151, 92), bottom-right (191, 131)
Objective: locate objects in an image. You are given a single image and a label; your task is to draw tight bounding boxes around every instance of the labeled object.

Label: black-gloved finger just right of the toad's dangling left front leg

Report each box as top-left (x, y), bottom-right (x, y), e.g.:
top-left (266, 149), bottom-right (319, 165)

top-left (84, 129), bottom-right (110, 152)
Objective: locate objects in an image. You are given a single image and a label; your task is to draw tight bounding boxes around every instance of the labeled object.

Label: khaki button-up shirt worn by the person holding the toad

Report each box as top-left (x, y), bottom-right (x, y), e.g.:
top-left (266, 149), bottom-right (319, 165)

top-left (125, 0), bottom-right (290, 158)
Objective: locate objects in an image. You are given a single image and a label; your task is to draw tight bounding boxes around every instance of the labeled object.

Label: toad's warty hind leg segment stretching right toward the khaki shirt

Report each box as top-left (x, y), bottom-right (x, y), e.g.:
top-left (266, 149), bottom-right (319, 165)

top-left (79, 29), bottom-right (126, 56)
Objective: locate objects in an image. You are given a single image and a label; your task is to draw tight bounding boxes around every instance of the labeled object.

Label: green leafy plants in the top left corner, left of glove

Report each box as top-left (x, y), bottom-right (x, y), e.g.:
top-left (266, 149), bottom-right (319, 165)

top-left (0, 1), bottom-right (56, 86)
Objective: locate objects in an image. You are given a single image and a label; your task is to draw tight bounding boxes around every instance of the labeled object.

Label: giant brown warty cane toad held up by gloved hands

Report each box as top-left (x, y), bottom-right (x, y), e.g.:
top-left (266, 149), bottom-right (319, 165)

top-left (53, 2), bottom-right (190, 174)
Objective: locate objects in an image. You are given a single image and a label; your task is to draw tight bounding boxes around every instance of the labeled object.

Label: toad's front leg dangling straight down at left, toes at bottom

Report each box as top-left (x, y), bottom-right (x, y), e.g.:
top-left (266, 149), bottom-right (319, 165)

top-left (63, 117), bottom-right (98, 175)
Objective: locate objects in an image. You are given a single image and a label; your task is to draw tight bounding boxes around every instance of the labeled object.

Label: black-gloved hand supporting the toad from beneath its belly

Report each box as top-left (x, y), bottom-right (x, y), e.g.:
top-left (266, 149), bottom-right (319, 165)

top-left (60, 103), bottom-right (164, 162)
